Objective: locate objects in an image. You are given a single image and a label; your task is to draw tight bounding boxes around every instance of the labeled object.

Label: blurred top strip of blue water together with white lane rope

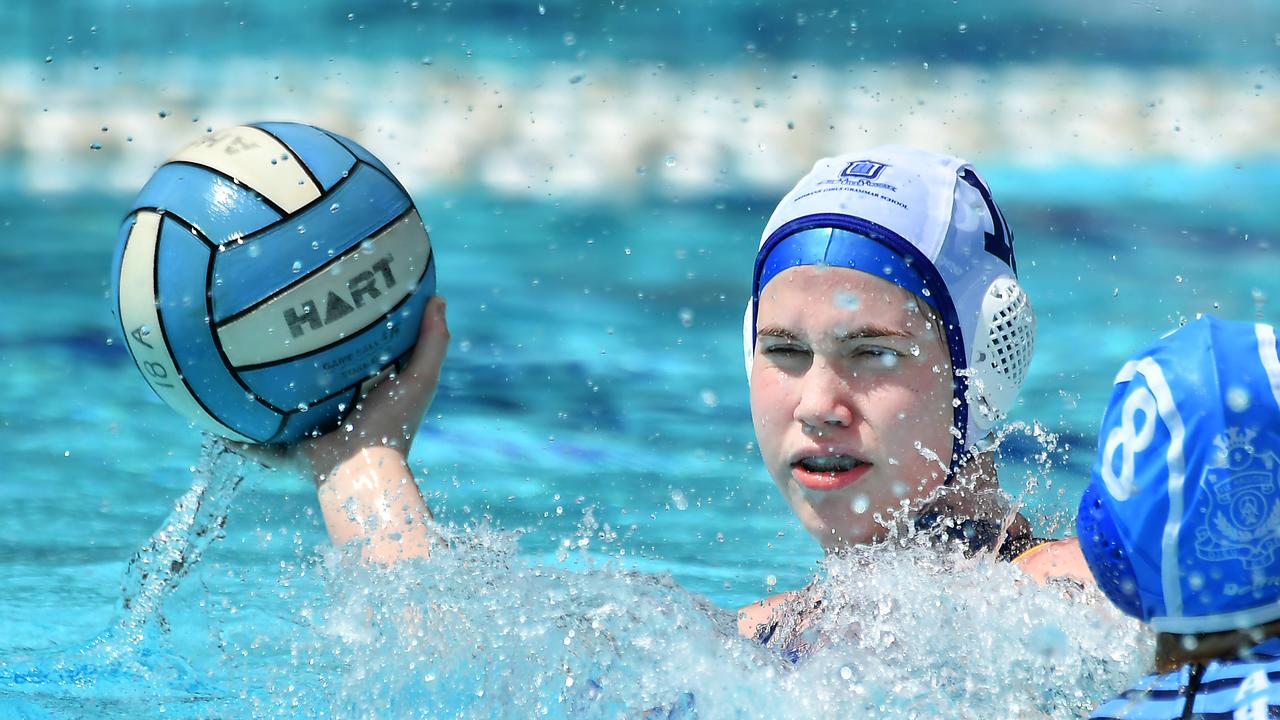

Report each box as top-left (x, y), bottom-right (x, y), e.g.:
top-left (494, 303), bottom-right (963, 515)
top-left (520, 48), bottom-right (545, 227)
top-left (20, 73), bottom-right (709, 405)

top-left (0, 0), bottom-right (1280, 193)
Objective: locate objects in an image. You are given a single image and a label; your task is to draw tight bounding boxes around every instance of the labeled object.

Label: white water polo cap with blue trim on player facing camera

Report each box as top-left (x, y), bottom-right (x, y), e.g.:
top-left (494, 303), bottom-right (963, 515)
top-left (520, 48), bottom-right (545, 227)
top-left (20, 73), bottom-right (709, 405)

top-left (744, 145), bottom-right (1036, 453)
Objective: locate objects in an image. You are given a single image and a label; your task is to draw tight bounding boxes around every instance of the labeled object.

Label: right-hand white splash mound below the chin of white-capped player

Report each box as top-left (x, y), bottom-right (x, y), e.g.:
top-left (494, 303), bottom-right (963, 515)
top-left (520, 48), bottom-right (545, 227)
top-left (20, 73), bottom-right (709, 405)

top-left (780, 543), bottom-right (1151, 717)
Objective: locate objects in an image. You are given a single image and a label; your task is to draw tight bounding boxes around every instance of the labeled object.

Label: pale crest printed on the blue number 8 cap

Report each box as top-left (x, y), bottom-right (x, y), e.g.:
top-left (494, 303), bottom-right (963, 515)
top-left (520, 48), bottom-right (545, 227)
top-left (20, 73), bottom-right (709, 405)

top-left (1196, 428), bottom-right (1280, 570)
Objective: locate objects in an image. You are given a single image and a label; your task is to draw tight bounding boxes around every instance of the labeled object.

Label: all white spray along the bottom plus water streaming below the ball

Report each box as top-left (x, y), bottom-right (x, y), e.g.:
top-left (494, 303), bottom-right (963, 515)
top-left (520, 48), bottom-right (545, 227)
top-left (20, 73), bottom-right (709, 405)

top-left (2, 420), bottom-right (1151, 719)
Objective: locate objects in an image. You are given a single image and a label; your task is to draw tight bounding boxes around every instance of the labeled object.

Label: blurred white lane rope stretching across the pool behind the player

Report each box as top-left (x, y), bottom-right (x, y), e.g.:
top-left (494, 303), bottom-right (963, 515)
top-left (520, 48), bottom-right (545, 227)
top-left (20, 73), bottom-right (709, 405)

top-left (0, 56), bottom-right (1280, 199)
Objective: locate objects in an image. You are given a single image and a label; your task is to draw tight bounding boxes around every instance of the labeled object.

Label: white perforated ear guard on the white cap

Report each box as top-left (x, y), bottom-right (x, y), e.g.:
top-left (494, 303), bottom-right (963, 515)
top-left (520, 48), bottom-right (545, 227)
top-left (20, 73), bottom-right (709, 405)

top-left (966, 275), bottom-right (1036, 430)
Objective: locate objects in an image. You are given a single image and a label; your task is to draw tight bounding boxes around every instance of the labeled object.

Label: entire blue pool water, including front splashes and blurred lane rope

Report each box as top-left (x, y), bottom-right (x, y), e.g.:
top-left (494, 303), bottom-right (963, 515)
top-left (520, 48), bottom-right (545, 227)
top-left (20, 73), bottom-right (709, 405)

top-left (0, 1), bottom-right (1280, 717)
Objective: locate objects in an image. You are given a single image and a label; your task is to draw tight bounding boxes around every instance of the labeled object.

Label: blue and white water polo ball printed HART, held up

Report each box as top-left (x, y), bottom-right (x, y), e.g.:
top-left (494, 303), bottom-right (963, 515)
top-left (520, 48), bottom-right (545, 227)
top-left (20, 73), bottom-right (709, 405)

top-left (113, 123), bottom-right (435, 443)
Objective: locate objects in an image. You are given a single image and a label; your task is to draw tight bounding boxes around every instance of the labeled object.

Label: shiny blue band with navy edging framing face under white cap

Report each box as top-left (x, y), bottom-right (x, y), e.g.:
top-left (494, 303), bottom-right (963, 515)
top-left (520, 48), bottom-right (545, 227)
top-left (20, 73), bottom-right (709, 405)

top-left (751, 213), bottom-right (969, 473)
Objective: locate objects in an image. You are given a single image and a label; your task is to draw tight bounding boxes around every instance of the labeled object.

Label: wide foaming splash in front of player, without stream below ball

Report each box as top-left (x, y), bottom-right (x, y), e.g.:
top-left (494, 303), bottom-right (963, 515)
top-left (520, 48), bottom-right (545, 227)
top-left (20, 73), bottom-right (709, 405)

top-left (241, 517), bottom-right (1151, 719)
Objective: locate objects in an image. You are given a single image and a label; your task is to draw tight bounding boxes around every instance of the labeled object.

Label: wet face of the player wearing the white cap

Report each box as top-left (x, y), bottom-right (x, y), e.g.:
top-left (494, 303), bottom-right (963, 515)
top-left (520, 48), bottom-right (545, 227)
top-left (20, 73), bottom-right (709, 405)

top-left (751, 265), bottom-right (954, 550)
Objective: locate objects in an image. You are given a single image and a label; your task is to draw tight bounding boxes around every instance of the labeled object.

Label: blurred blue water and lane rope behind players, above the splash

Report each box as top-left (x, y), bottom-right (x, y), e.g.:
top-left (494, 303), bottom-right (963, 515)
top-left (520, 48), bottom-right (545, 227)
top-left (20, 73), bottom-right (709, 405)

top-left (0, 0), bottom-right (1280, 691)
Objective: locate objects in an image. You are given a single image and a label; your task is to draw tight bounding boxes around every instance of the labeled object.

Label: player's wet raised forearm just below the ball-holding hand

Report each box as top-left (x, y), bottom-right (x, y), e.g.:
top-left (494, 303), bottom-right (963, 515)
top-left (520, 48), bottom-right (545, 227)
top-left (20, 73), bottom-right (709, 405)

top-left (316, 447), bottom-right (431, 564)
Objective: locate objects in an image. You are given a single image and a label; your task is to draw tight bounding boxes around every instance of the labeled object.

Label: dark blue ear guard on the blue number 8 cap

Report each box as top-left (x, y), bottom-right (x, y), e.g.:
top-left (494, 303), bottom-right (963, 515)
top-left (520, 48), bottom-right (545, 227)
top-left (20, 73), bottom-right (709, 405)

top-left (1075, 483), bottom-right (1151, 620)
